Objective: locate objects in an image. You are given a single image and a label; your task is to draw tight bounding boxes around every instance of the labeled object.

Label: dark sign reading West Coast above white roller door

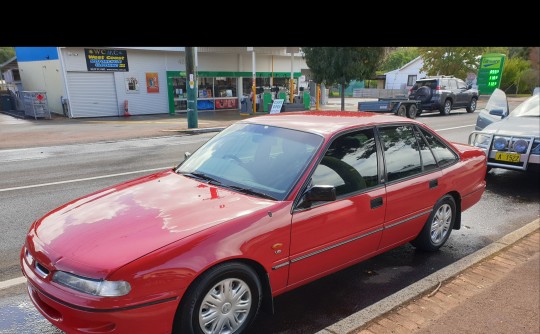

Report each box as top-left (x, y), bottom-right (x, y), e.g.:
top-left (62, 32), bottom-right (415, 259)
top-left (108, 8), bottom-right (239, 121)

top-left (84, 49), bottom-right (129, 72)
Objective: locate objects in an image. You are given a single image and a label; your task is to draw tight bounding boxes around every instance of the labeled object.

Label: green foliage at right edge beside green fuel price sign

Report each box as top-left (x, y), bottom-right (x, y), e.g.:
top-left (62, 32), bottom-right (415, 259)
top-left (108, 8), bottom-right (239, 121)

top-left (500, 57), bottom-right (539, 94)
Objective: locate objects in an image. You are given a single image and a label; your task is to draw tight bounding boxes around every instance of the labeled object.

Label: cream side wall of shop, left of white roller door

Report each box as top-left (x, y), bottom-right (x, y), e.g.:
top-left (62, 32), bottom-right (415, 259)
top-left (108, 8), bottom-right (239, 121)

top-left (18, 59), bottom-right (64, 114)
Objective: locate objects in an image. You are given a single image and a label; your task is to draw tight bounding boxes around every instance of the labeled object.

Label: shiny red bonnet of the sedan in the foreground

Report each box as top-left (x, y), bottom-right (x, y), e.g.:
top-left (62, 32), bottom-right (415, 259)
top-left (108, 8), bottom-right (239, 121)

top-left (28, 171), bottom-right (276, 274)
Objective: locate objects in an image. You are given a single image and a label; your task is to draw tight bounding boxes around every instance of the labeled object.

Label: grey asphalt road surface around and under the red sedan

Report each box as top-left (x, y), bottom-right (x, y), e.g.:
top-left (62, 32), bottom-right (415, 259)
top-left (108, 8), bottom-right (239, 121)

top-left (0, 110), bottom-right (540, 334)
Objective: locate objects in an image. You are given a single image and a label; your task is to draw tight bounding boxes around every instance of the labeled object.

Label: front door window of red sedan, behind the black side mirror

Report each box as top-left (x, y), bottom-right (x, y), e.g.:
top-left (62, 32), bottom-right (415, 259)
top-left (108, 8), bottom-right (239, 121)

top-left (312, 129), bottom-right (378, 197)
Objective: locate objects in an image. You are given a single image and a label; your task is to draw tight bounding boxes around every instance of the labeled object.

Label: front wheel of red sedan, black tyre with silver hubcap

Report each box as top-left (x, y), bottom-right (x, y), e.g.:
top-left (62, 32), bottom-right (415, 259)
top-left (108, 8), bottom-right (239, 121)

top-left (173, 262), bottom-right (262, 334)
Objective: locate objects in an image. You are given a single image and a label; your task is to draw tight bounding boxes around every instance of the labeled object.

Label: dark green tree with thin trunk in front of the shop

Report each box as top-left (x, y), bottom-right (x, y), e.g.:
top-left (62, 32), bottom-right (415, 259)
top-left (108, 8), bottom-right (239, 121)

top-left (302, 47), bottom-right (384, 111)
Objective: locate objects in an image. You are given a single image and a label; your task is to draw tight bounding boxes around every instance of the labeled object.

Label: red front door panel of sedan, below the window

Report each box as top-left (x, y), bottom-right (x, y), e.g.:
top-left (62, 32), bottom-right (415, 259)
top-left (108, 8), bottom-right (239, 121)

top-left (289, 187), bottom-right (386, 284)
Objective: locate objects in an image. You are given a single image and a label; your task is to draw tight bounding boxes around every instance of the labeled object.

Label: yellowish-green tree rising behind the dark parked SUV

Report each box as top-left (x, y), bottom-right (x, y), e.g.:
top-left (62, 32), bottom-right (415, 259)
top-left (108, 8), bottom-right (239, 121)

top-left (418, 47), bottom-right (486, 79)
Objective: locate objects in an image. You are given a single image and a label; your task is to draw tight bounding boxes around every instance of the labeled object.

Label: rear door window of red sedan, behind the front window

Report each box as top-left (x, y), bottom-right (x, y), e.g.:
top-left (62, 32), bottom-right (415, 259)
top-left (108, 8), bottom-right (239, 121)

top-left (379, 125), bottom-right (422, 182)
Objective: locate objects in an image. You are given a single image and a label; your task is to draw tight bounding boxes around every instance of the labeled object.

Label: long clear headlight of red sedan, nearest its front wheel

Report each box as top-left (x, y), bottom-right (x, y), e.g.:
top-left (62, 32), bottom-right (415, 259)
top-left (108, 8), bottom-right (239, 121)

top-left (53, 271), bottom-right (131, 297)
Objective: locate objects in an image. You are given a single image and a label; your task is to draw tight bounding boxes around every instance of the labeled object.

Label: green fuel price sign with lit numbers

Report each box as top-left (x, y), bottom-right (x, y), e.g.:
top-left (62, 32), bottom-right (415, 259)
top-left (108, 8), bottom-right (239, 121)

top-left (476, 53), bottom-right (506, 95)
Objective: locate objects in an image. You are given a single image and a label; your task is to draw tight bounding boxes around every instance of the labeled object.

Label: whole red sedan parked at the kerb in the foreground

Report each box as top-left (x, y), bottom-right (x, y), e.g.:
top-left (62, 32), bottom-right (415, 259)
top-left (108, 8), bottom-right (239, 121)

top-left (20, 111), bottom-right (486, 334)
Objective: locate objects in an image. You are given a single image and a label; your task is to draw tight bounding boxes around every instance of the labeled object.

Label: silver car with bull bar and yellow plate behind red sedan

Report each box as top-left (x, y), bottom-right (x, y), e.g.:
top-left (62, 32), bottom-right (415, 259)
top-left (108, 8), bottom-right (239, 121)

top-left (469, 88), bottom-right (540, 172)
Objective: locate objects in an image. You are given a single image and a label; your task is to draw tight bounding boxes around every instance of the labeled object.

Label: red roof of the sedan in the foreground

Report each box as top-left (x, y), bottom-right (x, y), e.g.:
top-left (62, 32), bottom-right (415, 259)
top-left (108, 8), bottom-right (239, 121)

top-left (241, 111), bottom-right (422, 137)
